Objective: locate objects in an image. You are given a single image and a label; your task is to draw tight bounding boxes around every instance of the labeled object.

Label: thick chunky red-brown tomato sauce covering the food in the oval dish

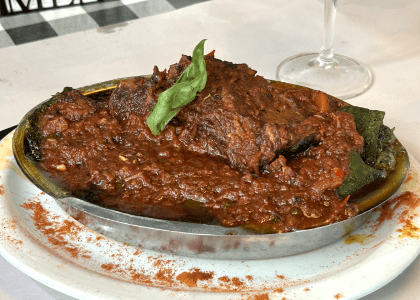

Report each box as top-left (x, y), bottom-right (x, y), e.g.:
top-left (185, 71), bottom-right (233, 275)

top-left (33, 56), bottom-right (363, 233)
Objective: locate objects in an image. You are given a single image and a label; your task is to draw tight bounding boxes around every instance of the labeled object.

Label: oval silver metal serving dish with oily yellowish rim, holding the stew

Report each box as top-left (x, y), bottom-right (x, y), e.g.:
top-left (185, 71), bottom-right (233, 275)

top-left (13, 78), bottom-right (410, 260)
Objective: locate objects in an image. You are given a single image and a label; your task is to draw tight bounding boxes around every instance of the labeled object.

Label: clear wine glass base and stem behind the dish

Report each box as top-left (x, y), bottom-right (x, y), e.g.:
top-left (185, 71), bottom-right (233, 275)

top-left (275, 0), bottom-right (372, 100)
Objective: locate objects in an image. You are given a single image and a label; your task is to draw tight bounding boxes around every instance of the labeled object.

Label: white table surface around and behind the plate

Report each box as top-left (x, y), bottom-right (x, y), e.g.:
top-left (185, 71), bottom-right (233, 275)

top-left (0, 0), bottom-right (420, 300)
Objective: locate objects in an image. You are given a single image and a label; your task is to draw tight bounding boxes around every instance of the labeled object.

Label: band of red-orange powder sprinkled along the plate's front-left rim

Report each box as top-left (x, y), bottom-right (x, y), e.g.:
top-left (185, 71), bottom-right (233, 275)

top-left (17, 195), bottom-right (332, 300)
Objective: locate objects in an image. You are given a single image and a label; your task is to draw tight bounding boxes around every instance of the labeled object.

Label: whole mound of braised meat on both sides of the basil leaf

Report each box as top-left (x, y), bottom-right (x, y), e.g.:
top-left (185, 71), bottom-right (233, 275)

top-left (109, 52), bottom-right (352, 174)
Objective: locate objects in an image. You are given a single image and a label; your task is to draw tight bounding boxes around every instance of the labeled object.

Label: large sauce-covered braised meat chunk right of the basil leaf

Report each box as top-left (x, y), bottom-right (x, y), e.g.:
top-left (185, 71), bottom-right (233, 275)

top-left (177, 56), bottom-right (342, 174)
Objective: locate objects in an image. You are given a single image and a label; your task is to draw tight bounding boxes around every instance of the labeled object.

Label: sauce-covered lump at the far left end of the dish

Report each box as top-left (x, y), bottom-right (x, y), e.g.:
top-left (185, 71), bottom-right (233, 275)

top-left (39, 89), bottom-right (122, 177)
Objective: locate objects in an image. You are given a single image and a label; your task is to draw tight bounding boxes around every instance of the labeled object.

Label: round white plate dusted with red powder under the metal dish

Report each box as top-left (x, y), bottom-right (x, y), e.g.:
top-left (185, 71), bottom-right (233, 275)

top-left (0, 134), bottom-right (420, 300)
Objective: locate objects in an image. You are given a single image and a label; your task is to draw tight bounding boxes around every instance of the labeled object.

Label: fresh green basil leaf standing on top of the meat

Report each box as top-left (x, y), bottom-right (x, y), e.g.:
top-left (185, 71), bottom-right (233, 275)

top-left (147, 40), bottom-right (207, 135)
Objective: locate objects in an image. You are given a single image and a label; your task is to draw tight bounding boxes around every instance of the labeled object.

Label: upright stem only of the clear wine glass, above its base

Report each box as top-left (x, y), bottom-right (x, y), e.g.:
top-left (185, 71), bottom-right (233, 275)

top-left (318, 0), bottom-right (338, 64)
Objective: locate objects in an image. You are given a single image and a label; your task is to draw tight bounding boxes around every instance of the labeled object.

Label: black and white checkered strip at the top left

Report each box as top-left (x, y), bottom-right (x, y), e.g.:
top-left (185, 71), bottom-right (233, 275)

top-left (0, 0), bottom-right (209, 48)
